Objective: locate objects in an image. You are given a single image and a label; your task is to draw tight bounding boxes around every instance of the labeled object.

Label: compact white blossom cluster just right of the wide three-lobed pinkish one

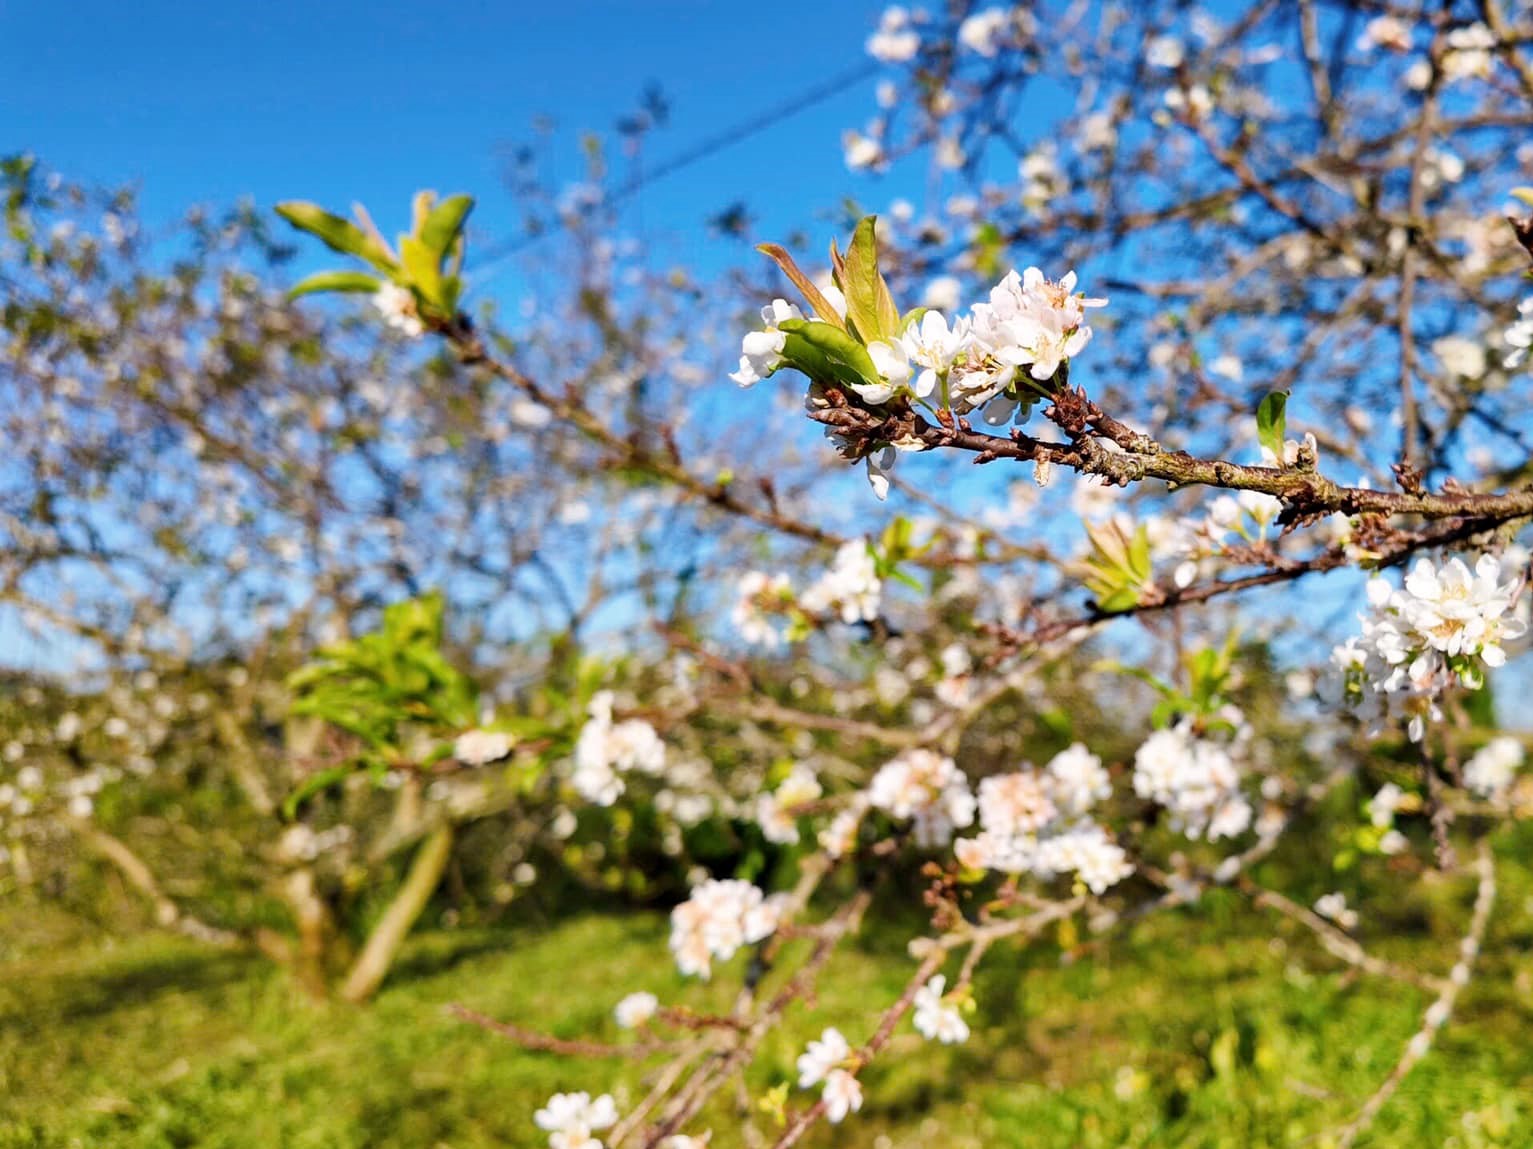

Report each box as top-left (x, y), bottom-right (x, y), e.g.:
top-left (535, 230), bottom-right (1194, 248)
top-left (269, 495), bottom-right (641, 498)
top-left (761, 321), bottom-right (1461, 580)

top-left (1134, 722), bottom-right (1251, 841)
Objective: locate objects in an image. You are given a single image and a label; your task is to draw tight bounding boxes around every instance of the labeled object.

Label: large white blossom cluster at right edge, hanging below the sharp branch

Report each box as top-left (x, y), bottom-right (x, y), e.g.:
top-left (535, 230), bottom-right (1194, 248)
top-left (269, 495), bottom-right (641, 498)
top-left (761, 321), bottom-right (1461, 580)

top-left (1323, 555), bottom-right (1527, 741)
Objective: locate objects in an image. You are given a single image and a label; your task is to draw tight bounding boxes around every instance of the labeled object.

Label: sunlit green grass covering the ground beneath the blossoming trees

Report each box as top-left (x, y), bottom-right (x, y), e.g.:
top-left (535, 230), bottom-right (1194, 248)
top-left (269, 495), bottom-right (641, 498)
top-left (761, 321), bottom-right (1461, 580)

top-left (0, 849), bottom-right (1533, 1149)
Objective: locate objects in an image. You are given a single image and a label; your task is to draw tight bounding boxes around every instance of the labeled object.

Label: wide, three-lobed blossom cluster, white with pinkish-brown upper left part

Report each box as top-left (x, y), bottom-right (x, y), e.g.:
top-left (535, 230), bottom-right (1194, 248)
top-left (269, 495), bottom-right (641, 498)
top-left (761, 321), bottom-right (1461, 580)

top-left (954, 743), bottom-right (1133, 893)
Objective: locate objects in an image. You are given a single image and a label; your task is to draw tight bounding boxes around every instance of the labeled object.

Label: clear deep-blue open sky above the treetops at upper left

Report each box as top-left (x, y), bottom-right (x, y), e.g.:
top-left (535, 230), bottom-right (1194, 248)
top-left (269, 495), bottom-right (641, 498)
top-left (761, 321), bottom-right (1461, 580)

top-left (0, 0), bottom-right (881, 272)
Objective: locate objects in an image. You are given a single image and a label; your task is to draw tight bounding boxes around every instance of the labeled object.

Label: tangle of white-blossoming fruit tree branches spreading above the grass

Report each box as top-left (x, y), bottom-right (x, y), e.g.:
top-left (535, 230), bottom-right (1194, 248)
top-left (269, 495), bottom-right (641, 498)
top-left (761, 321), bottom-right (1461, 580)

top-left (14, 3), bottom-right (1533, 1149)
